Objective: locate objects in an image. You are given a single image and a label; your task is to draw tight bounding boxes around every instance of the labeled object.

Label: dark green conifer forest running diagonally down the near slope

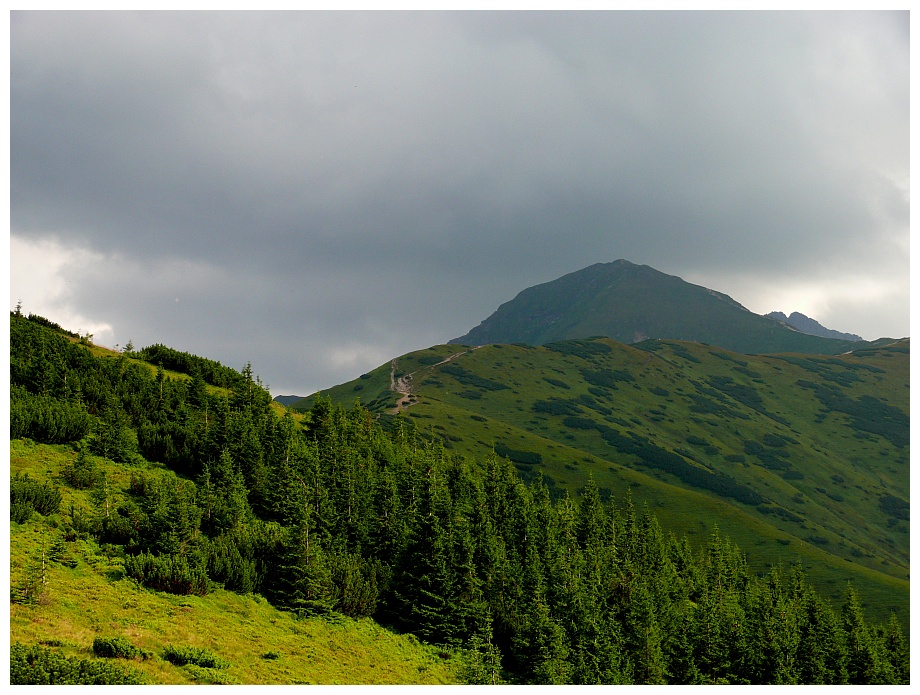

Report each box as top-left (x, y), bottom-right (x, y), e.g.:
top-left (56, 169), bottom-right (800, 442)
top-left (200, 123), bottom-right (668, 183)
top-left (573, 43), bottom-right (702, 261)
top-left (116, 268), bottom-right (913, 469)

top-left (10, 312), bottom-right (909, 684)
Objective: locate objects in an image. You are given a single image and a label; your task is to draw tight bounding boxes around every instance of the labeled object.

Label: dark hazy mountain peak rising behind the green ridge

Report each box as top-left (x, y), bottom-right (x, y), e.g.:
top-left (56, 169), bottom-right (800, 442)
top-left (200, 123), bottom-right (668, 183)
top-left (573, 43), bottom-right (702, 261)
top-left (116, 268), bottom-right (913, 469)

top-left (450, 259), bottom-right (868, 354)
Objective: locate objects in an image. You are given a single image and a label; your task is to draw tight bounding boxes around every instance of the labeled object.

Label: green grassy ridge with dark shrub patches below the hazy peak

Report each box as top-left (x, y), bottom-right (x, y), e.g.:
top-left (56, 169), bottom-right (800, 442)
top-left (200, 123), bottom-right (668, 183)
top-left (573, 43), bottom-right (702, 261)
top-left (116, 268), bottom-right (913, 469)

top-left (297, 339), bottom-right (909, 616)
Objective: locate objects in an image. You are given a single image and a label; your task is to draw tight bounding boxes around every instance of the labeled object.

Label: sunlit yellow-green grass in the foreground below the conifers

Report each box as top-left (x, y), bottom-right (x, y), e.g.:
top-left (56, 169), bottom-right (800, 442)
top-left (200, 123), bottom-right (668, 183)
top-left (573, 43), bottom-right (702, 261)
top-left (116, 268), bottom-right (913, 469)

top-left (10, 440), bottom-right (459, 685)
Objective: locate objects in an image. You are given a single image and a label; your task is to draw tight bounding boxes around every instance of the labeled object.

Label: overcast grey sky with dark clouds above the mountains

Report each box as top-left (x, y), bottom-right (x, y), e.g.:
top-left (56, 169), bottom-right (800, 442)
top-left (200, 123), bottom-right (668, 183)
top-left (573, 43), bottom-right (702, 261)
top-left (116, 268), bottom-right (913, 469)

top-left (10, 12), bottom-right (910, 395)
